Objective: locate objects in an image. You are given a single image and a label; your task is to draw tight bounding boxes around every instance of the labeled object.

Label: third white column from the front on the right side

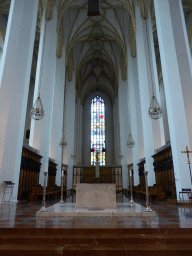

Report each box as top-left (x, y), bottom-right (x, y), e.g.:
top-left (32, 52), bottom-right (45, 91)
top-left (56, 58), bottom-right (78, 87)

top-left (128, 46), bottom-right (140, 186)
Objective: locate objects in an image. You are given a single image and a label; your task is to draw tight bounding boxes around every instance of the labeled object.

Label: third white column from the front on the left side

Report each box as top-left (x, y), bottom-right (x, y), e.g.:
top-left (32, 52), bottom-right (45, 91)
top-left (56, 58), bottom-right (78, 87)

top-left (49, 52), bottom-right (65, 186)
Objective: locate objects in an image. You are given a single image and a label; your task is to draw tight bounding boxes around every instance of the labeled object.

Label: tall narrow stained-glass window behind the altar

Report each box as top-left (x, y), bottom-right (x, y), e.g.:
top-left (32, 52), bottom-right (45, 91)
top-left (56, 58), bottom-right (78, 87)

top-left (91, 96), bottom-right (105, 165)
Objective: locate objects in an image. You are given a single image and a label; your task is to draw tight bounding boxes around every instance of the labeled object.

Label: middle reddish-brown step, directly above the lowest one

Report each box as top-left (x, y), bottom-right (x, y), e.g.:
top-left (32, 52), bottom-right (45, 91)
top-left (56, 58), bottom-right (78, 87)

top-left (0, 235), bottom-right (192, 245)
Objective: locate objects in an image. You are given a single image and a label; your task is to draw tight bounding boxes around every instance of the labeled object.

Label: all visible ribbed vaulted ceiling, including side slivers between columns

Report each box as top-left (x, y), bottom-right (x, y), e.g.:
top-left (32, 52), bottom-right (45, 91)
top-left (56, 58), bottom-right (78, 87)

top-left (0, 0), bottom-right (192, 100)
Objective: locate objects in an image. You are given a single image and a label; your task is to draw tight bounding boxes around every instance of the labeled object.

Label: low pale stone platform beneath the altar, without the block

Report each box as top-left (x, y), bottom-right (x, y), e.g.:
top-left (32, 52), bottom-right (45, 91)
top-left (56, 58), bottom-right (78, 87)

top-left (36, 202), bottom-right (156, 217)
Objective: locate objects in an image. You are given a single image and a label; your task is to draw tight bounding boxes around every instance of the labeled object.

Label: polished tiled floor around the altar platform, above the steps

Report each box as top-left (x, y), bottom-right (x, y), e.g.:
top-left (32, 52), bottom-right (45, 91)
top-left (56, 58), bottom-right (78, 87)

top-left (0, 196), bottom-right (192, 228)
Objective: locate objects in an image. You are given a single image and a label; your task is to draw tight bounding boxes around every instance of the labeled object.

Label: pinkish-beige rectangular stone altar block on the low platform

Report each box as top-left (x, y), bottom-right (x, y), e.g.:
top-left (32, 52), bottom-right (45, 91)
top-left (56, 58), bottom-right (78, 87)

top-left (76, 183), bottom-right (117, 209)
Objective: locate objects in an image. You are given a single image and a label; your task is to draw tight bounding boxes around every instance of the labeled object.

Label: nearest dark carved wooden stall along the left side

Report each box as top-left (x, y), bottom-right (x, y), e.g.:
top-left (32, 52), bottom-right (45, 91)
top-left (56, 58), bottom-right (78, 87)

top-left (18, 145), bottom-right (42, 200)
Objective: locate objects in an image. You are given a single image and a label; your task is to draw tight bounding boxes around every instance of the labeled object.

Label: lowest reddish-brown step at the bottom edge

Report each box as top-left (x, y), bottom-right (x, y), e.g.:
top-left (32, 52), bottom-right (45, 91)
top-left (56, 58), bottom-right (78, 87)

top-left (0, 244), bottom-right (192, 256)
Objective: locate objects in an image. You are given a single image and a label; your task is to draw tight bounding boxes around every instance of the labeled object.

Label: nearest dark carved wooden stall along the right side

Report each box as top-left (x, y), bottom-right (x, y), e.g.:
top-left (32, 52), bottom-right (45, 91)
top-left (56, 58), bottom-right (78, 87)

top-left (153, 144), bottom-right (176, 199)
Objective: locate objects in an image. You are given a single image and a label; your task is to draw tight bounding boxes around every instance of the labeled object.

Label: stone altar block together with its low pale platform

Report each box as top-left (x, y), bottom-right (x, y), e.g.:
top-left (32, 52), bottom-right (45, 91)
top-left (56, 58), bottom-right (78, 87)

top-left (36, 183), bottom-right (156, 217)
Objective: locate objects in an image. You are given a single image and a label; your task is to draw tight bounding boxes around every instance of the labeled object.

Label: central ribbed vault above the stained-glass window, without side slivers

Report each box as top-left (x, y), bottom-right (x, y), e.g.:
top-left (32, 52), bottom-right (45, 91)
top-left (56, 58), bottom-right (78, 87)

top-left (57, 0), bottom-right (135, 101)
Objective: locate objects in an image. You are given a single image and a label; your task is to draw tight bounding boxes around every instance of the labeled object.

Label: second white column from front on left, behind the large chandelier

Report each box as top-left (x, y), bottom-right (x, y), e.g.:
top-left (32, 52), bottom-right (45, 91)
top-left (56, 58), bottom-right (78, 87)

top-left (29, 6), bottom-right (58, 185)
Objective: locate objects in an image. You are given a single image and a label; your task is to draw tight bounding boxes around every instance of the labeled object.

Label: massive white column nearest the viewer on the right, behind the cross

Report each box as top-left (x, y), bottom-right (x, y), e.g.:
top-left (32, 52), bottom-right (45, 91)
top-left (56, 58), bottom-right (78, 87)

top-left (154, 0), bottom-right (192, 196)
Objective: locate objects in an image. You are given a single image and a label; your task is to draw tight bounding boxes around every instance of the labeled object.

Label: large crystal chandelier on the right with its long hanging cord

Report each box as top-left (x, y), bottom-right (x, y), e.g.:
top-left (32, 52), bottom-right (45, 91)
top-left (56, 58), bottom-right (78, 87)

top-left (145, 19), bottom-right (162, 119)
